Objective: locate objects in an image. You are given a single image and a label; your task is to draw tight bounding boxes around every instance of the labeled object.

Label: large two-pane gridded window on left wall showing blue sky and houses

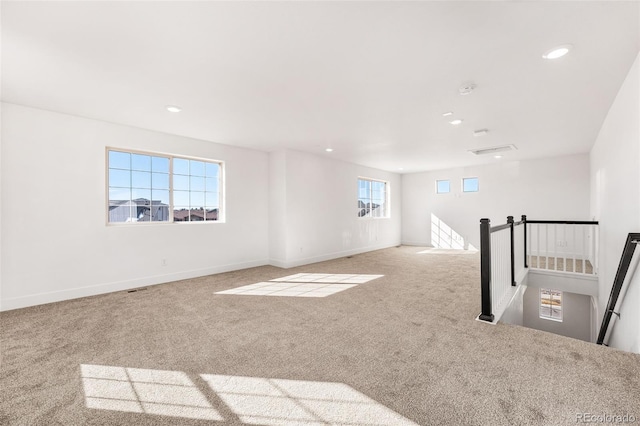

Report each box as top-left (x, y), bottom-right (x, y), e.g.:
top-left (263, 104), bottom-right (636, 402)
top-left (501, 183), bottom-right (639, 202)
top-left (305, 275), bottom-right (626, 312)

top-left (107, 149), bottom-right (223, 223)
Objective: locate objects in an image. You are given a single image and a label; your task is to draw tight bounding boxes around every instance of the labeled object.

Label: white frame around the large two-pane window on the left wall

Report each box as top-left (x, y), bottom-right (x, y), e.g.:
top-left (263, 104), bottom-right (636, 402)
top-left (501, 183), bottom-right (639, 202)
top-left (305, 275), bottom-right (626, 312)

top-left (105, 146), bottom-right (226, 226)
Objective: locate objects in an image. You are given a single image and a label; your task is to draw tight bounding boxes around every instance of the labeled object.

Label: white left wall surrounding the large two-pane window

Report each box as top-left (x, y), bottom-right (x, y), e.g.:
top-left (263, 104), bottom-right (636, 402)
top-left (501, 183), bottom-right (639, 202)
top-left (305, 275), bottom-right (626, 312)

top-left (0, 104), bottom-right (269, 309)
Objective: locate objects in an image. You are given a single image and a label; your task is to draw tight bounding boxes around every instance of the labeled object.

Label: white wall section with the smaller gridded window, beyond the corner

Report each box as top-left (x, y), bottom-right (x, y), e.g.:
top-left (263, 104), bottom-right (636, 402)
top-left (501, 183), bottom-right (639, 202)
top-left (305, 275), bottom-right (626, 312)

top-left (271, 150), bottom-right (402, 267)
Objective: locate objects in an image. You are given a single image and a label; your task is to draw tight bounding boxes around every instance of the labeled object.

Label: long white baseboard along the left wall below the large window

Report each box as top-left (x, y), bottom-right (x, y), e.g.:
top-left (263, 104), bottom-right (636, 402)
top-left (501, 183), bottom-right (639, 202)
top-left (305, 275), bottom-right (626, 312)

top-left (0, 260), bottom-right (269, 311)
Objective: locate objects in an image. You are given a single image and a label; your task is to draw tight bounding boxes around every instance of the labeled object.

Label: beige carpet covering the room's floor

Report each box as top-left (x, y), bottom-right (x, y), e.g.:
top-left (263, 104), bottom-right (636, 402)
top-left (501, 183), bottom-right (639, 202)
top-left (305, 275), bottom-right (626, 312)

top-left (0, 247), bottom-right (640, 426)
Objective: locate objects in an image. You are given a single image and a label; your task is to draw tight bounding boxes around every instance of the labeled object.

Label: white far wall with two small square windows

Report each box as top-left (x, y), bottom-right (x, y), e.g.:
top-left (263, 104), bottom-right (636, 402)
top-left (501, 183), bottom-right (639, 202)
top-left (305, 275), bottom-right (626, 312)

top-left (402, 154), bottom-right (590, 248)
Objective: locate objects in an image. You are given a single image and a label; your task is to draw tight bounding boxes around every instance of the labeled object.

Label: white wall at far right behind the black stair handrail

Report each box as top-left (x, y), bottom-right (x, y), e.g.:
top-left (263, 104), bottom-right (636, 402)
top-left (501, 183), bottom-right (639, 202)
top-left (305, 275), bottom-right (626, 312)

top-left (590, 55), bottom-right (640, 353)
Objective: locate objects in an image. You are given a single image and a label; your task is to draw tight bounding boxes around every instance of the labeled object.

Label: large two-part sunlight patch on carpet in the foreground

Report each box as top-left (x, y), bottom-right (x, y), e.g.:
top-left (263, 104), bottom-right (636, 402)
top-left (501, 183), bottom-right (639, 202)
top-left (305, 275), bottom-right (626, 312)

top-left (80, 364), bottom-right (417, 426)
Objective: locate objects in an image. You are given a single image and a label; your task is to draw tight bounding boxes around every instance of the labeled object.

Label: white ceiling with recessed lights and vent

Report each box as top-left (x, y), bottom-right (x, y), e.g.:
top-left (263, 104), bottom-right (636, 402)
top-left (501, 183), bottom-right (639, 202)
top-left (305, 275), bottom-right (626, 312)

top-left (1, 1), bottom-right (640, 172)
